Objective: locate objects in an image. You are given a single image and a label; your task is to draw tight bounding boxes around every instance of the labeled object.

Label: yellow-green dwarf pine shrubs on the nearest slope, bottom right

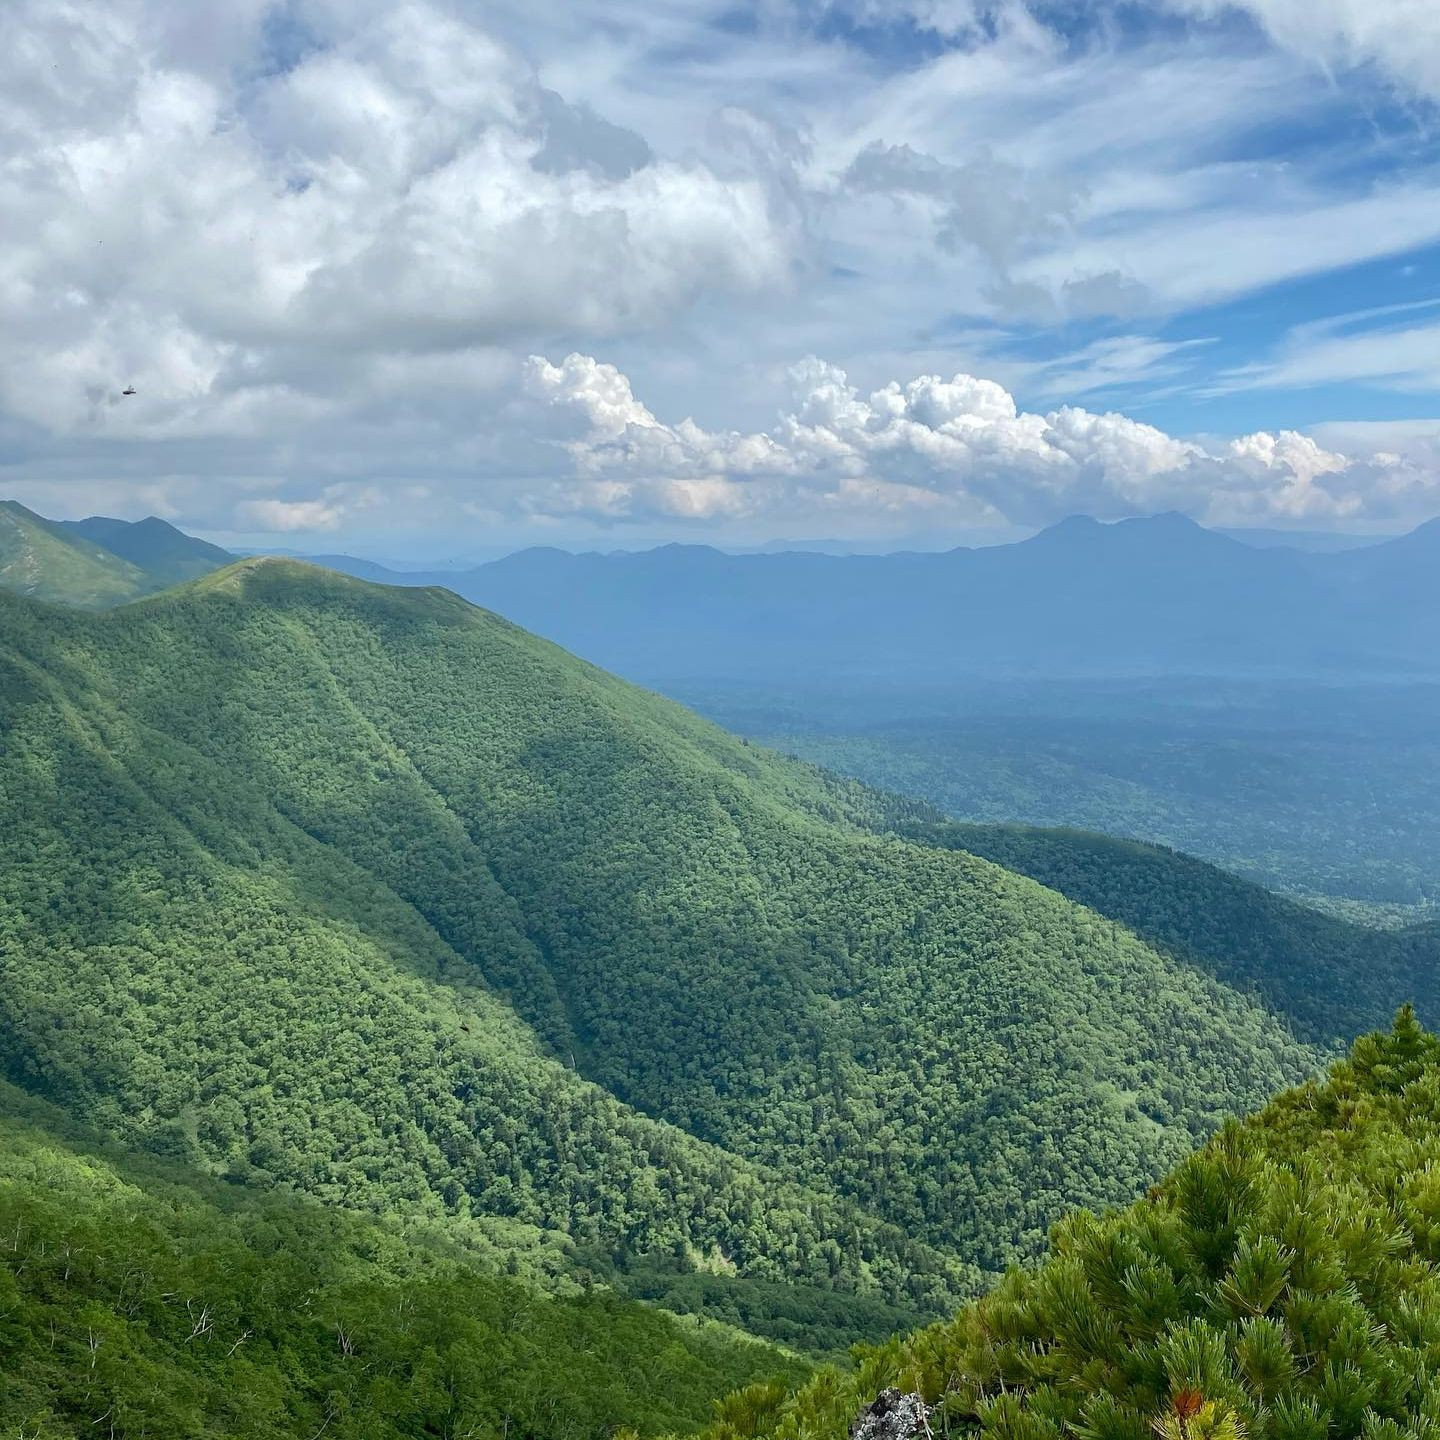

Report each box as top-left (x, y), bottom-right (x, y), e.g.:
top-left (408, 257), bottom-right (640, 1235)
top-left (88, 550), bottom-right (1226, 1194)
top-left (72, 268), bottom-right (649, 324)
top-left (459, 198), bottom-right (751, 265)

top-left (679, 1012), bottom-right (1440, 1440)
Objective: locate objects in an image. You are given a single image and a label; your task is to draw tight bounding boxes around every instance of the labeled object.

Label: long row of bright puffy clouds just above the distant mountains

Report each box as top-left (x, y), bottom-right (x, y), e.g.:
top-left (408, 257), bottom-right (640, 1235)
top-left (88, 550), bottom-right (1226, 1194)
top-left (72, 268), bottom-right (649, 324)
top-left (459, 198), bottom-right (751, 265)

top-left (526, 354), bottom-right (1440, 524)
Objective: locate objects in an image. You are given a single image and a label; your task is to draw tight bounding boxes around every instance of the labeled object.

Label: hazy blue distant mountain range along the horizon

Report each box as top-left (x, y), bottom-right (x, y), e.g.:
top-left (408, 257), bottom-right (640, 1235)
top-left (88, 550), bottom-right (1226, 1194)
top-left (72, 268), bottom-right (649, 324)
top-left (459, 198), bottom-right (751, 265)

top-left (280, 514), bottom-right (1440, 688)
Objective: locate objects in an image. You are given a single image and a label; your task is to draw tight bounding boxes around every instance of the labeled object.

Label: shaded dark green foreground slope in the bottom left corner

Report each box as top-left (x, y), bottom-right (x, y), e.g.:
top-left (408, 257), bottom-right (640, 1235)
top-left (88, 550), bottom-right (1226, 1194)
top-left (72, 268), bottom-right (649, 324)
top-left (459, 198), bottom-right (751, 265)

top-left (0, 1086), bottom-right (808, 1440)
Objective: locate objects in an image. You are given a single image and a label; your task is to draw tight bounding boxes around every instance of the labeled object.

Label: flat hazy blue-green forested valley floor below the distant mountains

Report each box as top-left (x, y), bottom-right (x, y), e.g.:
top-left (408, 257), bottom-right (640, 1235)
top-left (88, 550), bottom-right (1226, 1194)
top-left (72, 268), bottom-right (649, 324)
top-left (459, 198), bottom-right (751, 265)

top-left (743, 691), bottom-right (1440, 907)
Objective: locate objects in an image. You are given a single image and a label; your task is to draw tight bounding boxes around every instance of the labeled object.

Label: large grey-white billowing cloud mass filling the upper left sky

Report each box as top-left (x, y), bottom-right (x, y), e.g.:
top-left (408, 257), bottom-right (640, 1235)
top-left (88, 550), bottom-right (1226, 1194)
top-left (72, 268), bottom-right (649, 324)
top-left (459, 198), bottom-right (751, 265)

top-left (0, 0), bottom-right (799, 438)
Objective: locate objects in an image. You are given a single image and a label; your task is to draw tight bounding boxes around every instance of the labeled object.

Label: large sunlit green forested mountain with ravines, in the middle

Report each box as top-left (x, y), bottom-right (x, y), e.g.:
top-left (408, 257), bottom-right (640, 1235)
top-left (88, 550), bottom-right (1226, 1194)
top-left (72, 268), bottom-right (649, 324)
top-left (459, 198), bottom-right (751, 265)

top-left (0, 560), bottom-right (1347, 1308)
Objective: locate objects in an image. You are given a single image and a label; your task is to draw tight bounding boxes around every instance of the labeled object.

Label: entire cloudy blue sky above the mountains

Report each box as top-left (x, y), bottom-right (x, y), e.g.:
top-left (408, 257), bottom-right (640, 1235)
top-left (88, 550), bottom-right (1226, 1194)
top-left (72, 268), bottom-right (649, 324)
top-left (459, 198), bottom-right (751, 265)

top-left (0, 0), bottom-right (1440, 559)
